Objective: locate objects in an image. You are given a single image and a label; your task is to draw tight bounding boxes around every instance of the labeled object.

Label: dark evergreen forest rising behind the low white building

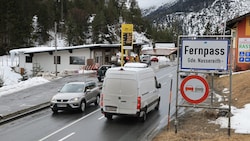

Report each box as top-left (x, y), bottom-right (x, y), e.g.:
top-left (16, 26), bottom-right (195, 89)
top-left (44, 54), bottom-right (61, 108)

top-left (0, 0), bottom-right (159, 55)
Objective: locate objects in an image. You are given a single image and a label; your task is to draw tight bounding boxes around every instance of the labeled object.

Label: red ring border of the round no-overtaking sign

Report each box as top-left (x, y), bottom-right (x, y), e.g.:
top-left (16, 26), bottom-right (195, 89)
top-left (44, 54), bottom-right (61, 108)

top-left (180, 75), bottom-right (209, 104)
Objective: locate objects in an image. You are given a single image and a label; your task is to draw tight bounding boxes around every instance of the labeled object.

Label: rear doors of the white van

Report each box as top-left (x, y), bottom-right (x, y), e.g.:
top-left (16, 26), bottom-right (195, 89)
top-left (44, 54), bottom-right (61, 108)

top-left (103, 78), bottom-right (138, 114)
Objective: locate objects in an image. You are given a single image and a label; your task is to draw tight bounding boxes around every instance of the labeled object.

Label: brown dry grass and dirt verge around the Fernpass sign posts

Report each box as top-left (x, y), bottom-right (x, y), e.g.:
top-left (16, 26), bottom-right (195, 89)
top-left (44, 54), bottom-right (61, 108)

top-left (153, 71), bottom-right (250, 141)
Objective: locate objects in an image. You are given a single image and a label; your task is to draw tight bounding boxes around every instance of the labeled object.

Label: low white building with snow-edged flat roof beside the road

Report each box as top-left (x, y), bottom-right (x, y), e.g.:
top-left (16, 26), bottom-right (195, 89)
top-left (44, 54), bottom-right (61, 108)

top-left (10, 44), bottom-right (120, 75)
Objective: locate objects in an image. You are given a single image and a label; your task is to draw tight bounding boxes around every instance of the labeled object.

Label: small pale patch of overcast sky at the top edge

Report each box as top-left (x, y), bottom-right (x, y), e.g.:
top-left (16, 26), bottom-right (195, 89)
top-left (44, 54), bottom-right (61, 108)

top-left (137, 0), bottom-right (174, 8)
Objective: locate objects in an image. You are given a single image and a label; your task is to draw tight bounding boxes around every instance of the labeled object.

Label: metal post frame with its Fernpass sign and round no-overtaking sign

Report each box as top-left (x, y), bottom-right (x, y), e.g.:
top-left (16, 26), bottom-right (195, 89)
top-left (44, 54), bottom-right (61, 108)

top-left (175, 35), bottom-right (233, 136)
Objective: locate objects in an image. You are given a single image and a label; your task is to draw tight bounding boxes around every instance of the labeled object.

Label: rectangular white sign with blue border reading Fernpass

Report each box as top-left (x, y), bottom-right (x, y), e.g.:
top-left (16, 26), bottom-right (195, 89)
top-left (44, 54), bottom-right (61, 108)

top-left (181, 39), bottom-right (229, 70)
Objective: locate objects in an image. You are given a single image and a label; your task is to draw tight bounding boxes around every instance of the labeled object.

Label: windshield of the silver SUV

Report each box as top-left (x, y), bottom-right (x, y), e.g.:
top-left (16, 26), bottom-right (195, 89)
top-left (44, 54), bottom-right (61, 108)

top-left (60, 84), bottom-right (84, 93)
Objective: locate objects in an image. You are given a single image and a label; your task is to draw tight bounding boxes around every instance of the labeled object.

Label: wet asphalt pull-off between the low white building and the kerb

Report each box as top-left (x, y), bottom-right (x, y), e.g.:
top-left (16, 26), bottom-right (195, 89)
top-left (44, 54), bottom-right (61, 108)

top-left (0, 73), bottom-right (97, 116)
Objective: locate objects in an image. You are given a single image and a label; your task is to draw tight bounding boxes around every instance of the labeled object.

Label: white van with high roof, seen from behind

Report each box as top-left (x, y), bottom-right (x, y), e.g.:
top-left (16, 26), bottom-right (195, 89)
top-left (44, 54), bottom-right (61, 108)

top-left (100, 63), bottom-right (161, 121)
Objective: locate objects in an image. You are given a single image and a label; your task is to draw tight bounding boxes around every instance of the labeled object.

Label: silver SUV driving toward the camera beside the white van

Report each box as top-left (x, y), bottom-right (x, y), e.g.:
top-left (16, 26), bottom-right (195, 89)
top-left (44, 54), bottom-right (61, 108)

top-left (50, 81), bottom-right (100, 113)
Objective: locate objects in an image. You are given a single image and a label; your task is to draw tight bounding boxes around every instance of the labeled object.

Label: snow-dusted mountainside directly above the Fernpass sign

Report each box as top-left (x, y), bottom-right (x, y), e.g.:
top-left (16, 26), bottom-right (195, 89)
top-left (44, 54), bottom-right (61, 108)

top-left (183, 0), bottom-right (250, 35)
